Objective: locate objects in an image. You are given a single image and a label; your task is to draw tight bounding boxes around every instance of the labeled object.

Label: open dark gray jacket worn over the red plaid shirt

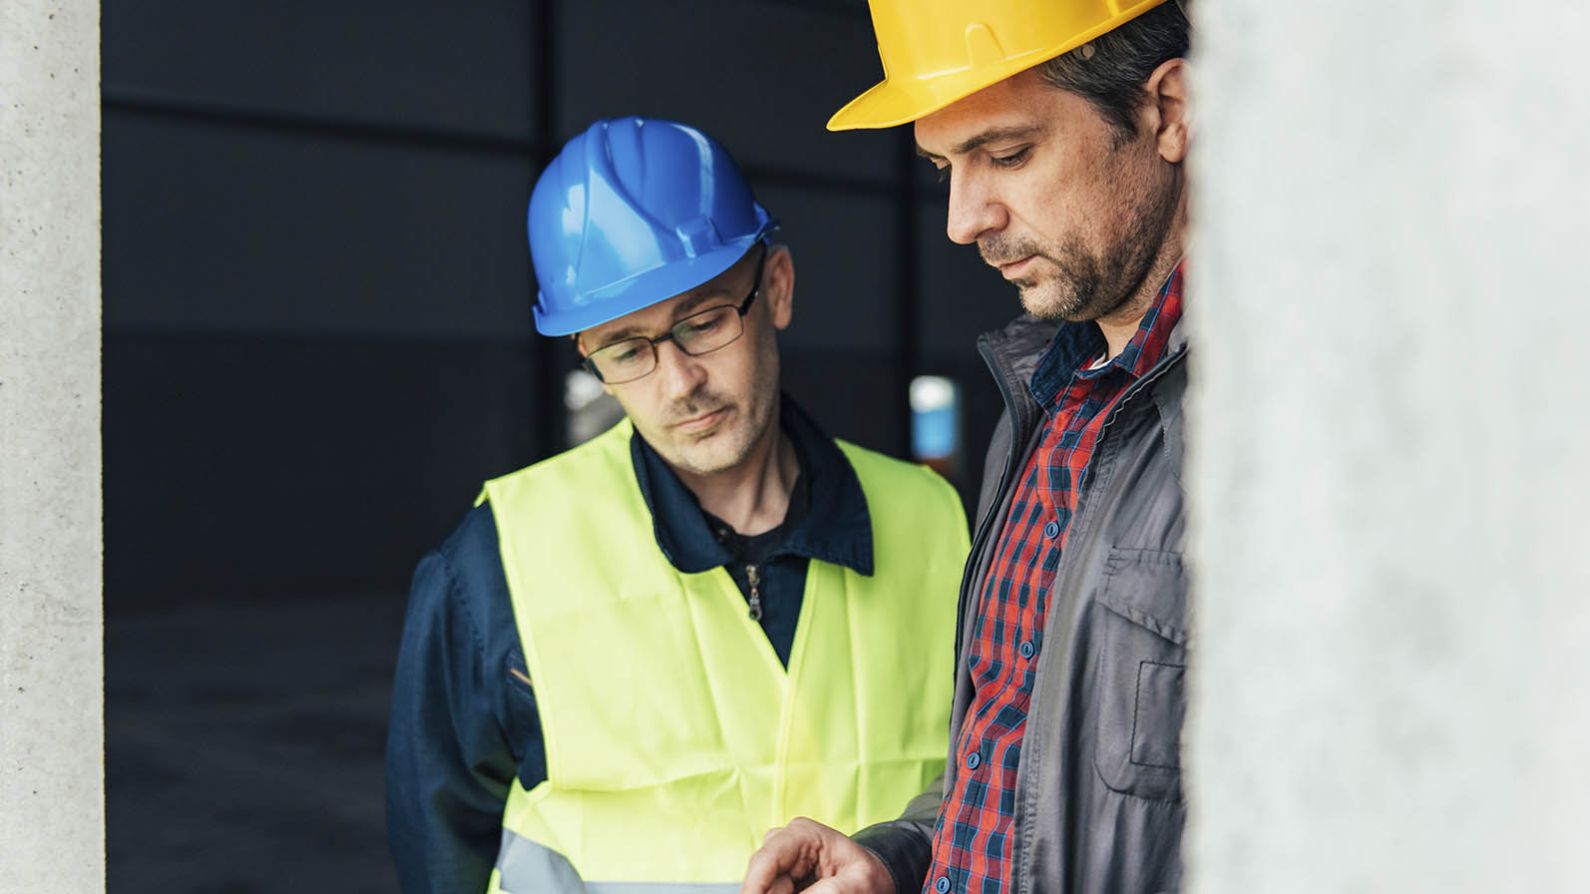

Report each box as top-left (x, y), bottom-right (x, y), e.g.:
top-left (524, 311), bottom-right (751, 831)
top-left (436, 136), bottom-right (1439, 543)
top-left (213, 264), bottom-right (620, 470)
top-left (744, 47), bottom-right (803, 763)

top-left (855, 308), bottom-right (1188, 894)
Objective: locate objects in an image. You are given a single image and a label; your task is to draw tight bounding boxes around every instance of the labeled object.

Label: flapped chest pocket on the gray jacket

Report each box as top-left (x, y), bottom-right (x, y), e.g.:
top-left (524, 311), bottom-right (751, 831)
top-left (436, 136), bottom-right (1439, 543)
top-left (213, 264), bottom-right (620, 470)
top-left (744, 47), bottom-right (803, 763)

top-left (1094, 549), bottom-right (1188, 802)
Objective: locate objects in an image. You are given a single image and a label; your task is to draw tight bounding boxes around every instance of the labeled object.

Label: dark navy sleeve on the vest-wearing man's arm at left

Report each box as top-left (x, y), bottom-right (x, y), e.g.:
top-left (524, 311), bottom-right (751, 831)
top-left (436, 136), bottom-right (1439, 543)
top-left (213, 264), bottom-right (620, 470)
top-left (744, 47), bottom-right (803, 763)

top-left (386, 552), bottom-right (515, 894)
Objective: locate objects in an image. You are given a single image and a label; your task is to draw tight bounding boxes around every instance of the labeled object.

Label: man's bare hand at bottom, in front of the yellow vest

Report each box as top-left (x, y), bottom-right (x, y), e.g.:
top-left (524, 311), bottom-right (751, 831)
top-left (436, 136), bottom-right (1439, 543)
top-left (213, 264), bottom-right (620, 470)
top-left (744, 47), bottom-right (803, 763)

top-left (739, 816), bottom-right (894, 894)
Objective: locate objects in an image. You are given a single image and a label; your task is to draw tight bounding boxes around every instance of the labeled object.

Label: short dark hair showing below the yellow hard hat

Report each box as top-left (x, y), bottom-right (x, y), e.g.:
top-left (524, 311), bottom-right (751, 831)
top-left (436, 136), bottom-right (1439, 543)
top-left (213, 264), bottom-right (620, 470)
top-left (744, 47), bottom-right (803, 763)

top-left (1038, 0), bottom-right (1189, 148)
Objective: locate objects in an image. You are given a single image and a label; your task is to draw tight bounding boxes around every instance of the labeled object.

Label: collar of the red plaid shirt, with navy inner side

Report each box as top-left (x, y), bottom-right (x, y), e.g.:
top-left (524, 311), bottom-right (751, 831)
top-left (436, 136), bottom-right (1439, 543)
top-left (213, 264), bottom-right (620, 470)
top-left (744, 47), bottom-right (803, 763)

top-left (1029, 264), bottom-right (1181, 407)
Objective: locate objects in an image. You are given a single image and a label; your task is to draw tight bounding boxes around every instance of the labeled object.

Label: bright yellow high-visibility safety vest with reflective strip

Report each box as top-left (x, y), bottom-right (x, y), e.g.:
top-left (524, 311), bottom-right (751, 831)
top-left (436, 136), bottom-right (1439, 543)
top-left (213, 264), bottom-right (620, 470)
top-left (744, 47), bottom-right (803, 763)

top-left (485, 420), bottom-right (968, 894)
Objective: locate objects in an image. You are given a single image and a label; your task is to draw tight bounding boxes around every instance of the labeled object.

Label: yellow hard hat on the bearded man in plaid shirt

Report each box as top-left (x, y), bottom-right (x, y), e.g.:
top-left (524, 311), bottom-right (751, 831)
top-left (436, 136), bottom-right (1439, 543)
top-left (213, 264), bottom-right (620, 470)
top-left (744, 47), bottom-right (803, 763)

top-left (828, 0), bottom-right (1165, 130)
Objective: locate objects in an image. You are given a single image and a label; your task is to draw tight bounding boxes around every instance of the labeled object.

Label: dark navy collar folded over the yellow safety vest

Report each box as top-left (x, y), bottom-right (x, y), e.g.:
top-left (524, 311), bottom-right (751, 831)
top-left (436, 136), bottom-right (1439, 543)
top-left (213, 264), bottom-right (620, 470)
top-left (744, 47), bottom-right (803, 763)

top-left (630, 395), bottom-right (873, 574)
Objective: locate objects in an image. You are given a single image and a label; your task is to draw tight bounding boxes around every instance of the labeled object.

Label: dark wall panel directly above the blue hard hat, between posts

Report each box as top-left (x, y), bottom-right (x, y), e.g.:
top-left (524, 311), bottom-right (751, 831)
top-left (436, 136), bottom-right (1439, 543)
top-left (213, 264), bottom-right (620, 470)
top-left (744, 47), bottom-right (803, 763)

top-left (557, 0), bottom-right (892, 181)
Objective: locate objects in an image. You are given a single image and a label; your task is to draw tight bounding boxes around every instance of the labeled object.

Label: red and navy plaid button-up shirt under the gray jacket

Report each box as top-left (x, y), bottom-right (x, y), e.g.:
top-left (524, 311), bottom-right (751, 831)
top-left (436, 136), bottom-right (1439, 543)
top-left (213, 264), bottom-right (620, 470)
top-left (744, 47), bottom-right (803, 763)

top-left (924, 267), bottom-right (1181, 894)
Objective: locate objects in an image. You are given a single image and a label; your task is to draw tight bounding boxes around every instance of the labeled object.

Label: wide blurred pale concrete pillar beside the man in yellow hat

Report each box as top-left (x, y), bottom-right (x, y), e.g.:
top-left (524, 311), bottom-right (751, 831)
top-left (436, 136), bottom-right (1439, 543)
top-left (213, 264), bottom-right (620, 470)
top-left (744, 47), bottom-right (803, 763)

top-left (1186, 0), bottom-right (1590, 894)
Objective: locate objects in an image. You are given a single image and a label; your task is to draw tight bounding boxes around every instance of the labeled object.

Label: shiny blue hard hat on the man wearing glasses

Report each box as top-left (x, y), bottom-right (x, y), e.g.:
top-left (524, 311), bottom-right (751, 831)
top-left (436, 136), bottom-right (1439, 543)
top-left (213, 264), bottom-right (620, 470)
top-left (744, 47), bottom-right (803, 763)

top-left (529, 118), bottom-right (778, 336)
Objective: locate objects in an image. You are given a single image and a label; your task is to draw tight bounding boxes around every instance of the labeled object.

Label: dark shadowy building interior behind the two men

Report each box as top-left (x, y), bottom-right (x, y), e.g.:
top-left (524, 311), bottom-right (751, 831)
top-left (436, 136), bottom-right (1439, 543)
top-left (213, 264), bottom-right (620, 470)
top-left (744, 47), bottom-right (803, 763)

top-left (103, 0), bottom-right (1018, 892)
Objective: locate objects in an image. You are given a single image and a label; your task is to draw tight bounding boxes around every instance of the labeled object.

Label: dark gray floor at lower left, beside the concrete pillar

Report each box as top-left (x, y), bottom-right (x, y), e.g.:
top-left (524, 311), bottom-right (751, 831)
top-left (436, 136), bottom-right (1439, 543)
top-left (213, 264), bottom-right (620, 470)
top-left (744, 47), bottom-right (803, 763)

top-left (105, 598), bottom-right (402, 894)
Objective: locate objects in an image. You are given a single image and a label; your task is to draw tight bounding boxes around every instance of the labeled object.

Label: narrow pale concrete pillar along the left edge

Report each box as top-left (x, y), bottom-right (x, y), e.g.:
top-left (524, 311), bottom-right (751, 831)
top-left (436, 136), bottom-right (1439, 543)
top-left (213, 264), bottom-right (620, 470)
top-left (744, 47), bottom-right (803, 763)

top-left (0, 0), bottom-right (105, 894)
